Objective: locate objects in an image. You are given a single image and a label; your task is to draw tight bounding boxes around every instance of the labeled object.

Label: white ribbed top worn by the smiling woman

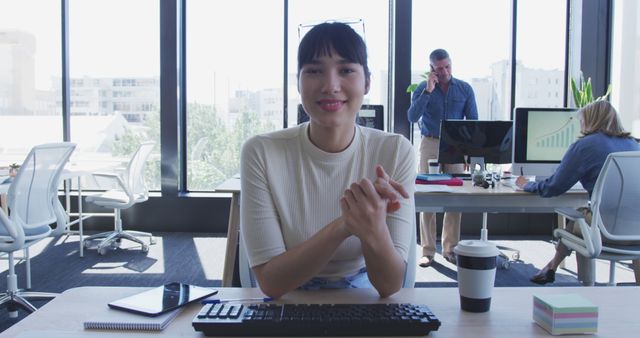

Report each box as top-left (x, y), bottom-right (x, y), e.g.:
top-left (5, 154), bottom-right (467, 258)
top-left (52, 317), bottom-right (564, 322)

top-left (240, 123), bottom-right (416, 277)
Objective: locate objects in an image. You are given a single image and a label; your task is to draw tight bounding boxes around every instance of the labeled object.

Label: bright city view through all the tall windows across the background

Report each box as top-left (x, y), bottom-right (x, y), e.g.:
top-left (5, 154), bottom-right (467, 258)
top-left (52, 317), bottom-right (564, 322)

top-left (5, 0), bottom-right (628, 191)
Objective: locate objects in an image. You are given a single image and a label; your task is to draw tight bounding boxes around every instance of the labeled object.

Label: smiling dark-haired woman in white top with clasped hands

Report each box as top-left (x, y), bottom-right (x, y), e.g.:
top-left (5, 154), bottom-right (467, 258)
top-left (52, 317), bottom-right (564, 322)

top-left (240, 23), bottom-right (415, 298)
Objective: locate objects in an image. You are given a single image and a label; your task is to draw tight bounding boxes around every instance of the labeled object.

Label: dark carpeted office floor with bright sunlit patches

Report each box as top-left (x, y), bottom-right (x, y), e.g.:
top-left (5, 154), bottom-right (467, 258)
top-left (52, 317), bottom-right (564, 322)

top-left (0, 233), bottom-right (634, 332)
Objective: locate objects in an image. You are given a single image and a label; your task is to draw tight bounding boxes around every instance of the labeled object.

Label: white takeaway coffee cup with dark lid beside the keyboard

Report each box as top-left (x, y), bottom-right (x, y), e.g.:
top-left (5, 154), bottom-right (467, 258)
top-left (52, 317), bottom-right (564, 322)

top-left (453, 240), bottom-right (499, 312)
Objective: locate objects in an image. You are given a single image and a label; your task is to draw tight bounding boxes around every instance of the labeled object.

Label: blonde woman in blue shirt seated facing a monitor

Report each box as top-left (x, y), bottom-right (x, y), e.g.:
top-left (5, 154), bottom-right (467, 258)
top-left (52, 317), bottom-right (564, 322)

top-left (516, 101), bottom-right (640, 284)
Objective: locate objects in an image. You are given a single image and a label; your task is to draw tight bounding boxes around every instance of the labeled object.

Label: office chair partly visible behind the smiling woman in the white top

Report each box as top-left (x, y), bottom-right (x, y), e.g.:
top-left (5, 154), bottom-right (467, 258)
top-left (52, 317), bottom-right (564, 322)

top-left (238, 218), bottom-right (417, 288)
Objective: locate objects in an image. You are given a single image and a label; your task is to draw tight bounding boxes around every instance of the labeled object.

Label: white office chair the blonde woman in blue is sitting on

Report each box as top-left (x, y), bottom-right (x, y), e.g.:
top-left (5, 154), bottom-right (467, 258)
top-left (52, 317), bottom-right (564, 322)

top-left (554, 151), bottom-right (640, 285)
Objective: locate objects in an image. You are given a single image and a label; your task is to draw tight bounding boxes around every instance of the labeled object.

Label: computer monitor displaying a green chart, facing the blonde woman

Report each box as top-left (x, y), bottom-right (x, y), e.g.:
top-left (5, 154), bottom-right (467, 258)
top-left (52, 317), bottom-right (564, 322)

top-left (512, 107), bottom-right (581, 180)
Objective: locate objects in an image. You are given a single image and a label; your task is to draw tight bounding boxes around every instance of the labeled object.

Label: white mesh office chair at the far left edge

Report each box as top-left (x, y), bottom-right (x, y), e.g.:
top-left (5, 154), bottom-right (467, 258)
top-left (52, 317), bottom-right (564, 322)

top-left (0, 143), bottom-right (75, 318)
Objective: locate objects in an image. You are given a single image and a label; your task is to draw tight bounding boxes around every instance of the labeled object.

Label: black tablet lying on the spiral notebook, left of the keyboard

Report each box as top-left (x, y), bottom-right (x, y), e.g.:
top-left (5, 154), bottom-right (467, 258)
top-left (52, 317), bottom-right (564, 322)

top-left (108, 282), bottom-right (218, 317)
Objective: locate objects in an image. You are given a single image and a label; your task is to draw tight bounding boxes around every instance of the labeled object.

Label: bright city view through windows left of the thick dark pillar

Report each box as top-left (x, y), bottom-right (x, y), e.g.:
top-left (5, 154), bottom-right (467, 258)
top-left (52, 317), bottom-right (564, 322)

top-left (0, 0), bottom-right (160, 189)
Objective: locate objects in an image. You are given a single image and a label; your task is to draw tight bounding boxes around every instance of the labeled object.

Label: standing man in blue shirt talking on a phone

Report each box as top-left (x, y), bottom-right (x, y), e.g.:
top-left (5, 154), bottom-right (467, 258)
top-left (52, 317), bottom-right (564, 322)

top-left (407, 49), bottom-right (478, 267)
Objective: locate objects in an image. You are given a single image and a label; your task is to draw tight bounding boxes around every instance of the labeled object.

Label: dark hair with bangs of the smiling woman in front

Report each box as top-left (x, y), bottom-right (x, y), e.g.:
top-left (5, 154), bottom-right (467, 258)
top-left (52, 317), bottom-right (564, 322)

top-left (298, 22), bottom-right (371, 79)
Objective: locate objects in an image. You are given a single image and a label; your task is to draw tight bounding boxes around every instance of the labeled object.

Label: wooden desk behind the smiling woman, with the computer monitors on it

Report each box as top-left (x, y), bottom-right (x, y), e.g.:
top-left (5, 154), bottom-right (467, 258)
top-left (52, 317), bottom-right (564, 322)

top-left (215, 177), bottom-right (588, 287)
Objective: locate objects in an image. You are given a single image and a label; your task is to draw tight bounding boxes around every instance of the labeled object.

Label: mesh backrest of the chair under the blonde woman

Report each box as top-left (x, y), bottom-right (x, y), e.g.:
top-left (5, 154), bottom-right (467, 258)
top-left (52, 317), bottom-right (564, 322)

top-left (591, 151), bottom-right (640, 241)
